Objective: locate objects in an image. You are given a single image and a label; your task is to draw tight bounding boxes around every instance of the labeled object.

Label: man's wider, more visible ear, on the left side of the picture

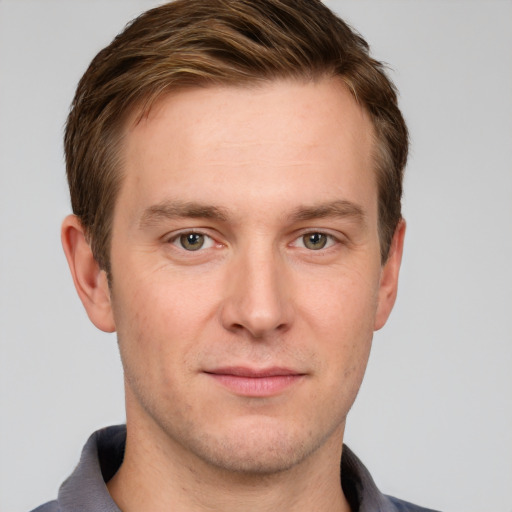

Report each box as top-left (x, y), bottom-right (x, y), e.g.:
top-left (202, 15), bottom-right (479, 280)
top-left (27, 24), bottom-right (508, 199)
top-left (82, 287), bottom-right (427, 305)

top-left (61, 215), bottom-right (116, 332)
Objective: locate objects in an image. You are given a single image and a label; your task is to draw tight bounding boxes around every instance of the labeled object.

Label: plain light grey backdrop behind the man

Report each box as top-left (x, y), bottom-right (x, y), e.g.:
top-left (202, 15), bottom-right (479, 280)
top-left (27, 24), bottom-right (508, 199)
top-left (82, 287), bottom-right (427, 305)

top-left (0, 0), bottom-right (512, 512)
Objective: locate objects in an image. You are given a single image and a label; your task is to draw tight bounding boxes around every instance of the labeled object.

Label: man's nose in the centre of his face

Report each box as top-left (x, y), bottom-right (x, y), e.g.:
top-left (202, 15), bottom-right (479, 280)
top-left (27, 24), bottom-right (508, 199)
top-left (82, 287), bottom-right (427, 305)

top-left (221, 248), bottom-right (293, 339)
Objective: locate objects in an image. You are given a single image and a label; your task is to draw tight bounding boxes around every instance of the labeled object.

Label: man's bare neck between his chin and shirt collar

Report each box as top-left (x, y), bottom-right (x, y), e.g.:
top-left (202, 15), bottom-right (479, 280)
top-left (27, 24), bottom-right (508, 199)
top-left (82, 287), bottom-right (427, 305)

top-left (107, 417), bottom-right (350, 512)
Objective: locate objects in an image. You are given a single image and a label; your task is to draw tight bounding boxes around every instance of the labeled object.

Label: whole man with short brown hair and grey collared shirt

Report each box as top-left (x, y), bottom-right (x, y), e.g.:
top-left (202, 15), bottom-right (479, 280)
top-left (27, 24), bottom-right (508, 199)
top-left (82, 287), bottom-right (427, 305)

top-left (33, 0), bottom-right (440, 512)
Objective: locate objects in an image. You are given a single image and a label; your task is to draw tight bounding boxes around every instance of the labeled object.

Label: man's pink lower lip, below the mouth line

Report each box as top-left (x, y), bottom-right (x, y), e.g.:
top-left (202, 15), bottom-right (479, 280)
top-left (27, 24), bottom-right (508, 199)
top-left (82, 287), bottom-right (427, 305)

top-left (208, 373), bottom-right (302, 397)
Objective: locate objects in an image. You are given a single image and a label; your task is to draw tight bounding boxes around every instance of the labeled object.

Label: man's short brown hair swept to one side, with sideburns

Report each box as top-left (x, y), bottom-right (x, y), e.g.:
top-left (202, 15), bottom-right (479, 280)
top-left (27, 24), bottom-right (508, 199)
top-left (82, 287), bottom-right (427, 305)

top-left (65, 0), bottom-right (408, 273)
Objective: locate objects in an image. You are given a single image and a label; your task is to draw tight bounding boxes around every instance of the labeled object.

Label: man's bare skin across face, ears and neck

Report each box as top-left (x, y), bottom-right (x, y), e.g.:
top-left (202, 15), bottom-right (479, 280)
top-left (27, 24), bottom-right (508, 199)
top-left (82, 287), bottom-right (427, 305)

top-left (62, 79), bottom-right (405, 512)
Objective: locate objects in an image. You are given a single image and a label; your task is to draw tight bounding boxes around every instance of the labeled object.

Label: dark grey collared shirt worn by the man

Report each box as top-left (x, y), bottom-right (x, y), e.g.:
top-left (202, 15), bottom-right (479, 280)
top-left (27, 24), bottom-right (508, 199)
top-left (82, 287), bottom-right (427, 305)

top-left (33, 425), bottom-right (435, 512)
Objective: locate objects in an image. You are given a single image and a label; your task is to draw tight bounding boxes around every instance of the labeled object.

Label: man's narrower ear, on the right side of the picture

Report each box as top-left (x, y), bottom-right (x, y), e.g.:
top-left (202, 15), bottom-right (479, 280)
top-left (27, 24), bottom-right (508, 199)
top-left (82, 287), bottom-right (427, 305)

top-left (373, 219), bottom-right (405, 331)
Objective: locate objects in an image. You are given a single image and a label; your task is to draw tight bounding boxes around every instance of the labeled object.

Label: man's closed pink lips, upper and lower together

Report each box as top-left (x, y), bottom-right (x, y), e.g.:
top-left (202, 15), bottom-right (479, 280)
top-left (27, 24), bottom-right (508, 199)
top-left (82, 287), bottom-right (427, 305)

top-left (204, 366), bottom-right (305, 398)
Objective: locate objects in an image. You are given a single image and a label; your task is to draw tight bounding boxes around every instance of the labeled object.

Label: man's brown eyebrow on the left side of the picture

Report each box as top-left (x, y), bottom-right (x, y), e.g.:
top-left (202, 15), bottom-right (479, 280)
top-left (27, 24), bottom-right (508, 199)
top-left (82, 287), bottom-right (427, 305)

top-left (139, 201), bottom-right (228, 228)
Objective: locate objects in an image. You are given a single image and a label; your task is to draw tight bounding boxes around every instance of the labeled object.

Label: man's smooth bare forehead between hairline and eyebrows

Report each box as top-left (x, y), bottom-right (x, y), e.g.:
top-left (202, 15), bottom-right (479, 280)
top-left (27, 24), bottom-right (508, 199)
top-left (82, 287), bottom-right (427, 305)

top-left (121, 79), bottom-right (376, 220)
